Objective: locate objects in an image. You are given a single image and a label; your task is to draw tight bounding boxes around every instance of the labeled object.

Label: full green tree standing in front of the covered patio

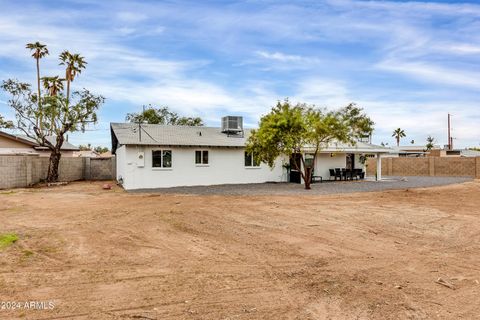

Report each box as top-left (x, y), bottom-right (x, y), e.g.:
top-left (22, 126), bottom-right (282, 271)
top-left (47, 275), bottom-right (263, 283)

top-left (247, 99), bottom-right (374, 189)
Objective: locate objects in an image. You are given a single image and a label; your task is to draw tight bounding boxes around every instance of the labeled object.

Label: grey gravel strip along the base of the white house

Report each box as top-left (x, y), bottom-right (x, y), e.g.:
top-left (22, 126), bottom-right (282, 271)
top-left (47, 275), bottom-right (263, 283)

top-left (130, 176), bottom-right (473, 195)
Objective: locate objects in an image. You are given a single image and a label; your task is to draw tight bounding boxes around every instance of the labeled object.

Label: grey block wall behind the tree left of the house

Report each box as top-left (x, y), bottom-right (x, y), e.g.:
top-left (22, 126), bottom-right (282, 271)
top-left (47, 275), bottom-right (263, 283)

top-left (0, 155), bottom-right (115, 189)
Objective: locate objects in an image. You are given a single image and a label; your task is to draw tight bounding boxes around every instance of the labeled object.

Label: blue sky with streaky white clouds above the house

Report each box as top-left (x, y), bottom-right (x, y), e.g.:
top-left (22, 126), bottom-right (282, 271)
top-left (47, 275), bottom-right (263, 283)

top-left (0, 0), bottom-right (480, 148)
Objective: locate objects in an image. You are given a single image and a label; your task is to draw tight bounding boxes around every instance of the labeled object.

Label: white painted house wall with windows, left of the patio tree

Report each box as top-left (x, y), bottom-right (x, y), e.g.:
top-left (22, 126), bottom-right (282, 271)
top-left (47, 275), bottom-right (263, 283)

top-left (117, 146), bottom-right (287, 190)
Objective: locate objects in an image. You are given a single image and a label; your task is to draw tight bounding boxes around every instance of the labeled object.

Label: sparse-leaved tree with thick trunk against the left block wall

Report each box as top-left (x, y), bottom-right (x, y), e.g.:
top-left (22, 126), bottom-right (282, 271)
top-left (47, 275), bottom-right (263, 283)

top-left (1, 42), bottom-right (105, 182)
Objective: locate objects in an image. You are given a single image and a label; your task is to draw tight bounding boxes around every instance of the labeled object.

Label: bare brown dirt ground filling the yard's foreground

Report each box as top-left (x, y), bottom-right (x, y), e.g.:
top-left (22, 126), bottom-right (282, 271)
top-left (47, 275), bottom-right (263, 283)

top-left (0, 180), bottom-right (480, 319)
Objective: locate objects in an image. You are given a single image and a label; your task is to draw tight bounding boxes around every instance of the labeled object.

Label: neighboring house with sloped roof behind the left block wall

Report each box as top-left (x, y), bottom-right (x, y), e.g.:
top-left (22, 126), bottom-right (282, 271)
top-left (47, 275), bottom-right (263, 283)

top-left (0, 131), bottom-right (79, 157)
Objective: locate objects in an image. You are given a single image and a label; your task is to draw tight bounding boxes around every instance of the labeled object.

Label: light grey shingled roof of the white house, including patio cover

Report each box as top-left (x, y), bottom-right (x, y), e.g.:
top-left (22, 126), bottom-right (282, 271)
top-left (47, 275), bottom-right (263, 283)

top-left (110, 123), bottom-right (391, 154)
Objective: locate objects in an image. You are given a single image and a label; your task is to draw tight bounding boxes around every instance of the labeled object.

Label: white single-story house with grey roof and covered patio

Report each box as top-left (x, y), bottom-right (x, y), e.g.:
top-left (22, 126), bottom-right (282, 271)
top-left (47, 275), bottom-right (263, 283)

top-left (110, 117), bottom-right (390, 190)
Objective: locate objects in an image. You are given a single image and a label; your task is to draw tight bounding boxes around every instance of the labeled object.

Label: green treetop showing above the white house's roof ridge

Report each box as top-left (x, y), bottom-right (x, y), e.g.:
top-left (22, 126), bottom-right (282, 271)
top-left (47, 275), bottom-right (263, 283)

top-left (125, 106), bottom-right (204, 126)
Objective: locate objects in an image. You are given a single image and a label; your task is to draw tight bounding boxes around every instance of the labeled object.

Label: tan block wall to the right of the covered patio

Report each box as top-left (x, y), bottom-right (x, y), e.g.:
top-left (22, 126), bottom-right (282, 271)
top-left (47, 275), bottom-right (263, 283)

top-left (367, 157), bottom-right (480, 178)
